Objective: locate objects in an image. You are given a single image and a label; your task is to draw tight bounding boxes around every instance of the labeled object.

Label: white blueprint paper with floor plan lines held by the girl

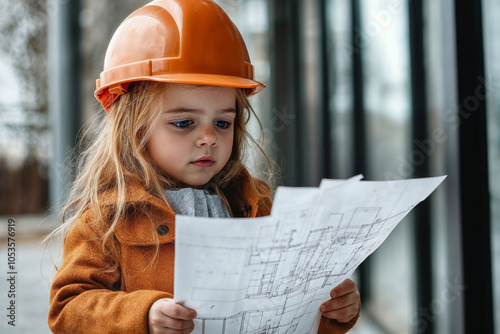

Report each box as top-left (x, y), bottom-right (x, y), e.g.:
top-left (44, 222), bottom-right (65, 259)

top-left (174, 176), bottom-right (445, 334)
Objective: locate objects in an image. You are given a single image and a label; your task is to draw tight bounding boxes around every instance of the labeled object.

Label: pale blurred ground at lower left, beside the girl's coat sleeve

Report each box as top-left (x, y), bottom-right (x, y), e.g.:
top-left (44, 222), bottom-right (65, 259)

top-left (0, 215), bottom-right (56, 334)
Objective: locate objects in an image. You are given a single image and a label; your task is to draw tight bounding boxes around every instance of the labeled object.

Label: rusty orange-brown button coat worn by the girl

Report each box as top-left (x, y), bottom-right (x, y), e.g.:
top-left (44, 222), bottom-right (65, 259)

top-left (48, 171), bottom-right (357, 334)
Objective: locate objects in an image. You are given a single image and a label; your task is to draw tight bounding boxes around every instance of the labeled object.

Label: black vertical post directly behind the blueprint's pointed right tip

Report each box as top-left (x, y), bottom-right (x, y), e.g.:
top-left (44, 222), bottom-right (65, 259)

top-left (408, 0), bottom-right (435, 334)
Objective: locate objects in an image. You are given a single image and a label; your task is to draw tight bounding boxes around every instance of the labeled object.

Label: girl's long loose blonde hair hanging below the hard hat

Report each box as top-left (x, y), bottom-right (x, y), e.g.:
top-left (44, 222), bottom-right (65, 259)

top-left (49, 81), bottom-right (272, 268)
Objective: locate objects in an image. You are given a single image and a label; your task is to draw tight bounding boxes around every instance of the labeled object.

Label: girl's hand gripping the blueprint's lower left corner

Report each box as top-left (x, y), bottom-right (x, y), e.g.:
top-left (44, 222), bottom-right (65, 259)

top-left (148, 298), bottom-right (196, 334)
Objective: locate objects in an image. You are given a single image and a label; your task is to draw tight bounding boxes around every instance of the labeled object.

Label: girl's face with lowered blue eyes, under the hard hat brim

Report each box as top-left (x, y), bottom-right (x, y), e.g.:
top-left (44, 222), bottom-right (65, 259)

top-left (148, 84), bottom-right (236, 187)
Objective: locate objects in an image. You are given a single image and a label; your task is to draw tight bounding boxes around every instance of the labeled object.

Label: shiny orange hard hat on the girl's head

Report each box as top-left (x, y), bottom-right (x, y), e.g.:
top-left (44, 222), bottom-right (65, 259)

top-left (95, 0), bottom-right (265, 110)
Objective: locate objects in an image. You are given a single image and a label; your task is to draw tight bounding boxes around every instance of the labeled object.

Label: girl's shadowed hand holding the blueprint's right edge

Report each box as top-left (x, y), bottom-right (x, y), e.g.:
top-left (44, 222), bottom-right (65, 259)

top-left (319, 279), bottom-right (361, 323)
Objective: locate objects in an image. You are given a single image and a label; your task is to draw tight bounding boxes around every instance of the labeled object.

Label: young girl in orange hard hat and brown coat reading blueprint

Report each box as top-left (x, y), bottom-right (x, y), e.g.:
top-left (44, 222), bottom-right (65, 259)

top-left (48, 0), bottom-right (360, 333)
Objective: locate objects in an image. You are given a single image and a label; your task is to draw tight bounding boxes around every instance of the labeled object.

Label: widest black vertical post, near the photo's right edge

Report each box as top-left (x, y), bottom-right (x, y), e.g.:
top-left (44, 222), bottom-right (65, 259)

top-left (455, 0), bottom-right (494, 334)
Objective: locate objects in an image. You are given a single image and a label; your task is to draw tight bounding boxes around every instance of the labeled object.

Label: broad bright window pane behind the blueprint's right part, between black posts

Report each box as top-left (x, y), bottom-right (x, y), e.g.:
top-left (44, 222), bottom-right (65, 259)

top-left (360, 0), bottom-right (415, 333)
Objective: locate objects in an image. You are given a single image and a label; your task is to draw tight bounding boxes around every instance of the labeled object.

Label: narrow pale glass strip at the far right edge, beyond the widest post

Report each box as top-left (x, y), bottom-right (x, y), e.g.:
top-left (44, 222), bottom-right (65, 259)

top-left (483, 0), bottom-right (500, 331)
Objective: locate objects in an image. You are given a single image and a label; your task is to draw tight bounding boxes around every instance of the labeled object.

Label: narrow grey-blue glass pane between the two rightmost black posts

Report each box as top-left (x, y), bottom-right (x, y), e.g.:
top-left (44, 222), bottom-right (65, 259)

top-left (424, 0), bottom-right (463, 334)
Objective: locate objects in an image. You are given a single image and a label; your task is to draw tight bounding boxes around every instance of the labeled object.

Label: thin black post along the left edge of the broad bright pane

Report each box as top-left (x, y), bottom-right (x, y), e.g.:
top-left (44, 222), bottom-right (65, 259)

top-left (351, 0), bottom-right (371, 303)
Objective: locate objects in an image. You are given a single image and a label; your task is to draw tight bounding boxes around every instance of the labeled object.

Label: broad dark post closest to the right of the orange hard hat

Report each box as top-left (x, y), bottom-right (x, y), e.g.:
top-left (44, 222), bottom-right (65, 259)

top-left (269, 0), bottom-right (304, 186)
